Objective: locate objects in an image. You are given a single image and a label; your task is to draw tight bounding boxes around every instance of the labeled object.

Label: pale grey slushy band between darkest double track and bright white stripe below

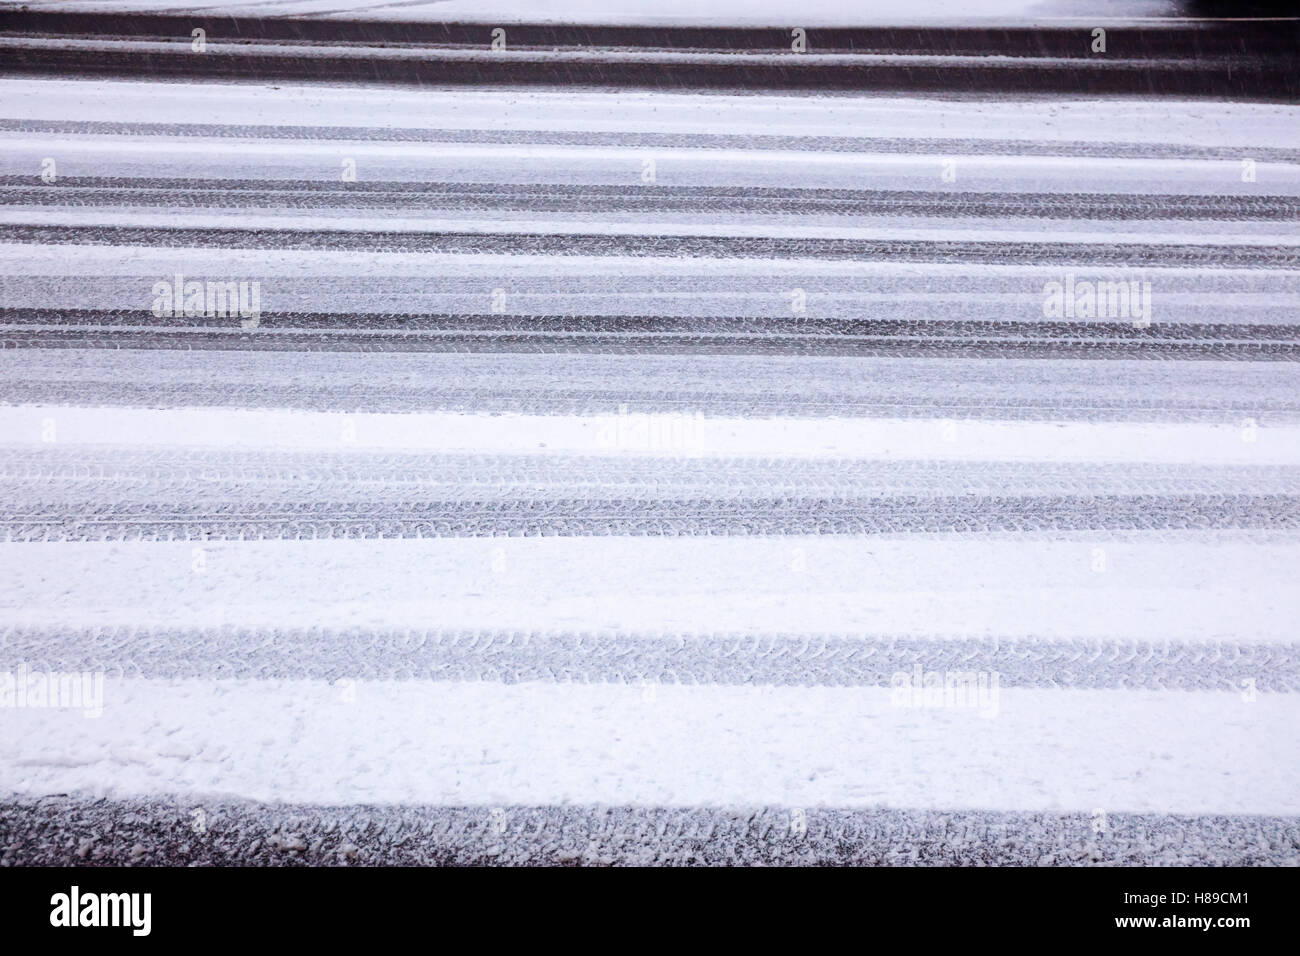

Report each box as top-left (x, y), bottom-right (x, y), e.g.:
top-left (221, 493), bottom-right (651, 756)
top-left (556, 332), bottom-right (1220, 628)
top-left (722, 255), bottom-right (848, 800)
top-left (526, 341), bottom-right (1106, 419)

top-left (10, 349), bottom-right (1300, 428)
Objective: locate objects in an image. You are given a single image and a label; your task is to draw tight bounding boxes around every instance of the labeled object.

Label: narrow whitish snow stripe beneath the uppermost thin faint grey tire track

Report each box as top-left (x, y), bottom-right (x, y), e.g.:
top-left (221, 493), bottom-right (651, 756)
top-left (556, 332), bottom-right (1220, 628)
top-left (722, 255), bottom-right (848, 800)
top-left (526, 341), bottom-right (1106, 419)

top-left (0, 140), bottom-right (1300, 195)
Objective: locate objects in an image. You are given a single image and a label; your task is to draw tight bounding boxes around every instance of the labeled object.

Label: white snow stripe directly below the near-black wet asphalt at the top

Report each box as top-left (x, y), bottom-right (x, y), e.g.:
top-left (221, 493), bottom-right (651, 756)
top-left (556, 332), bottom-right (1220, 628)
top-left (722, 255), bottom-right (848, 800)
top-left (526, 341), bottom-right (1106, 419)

top-left (0, 78), bottom-right (1300, 151)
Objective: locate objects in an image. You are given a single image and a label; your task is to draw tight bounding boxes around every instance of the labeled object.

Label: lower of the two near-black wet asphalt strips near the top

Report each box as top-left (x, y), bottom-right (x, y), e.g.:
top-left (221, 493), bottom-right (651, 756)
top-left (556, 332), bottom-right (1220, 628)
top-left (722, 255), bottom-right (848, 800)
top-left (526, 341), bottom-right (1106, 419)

top-left (0, 43), bottom-right (1300, 101)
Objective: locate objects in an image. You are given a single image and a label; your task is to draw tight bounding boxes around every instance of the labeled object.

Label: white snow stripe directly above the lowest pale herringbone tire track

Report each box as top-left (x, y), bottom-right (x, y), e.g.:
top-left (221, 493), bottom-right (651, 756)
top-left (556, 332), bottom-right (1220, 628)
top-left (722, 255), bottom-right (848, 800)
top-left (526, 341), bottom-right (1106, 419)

top-left (0, 532), bottom-right (1300, 642)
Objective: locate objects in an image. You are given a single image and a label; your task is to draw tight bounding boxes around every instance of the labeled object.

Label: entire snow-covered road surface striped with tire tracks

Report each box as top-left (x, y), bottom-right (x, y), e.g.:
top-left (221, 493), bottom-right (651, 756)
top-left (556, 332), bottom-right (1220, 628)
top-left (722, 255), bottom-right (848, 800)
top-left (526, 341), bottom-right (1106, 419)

top-left (0, 0), bottom-right (1300, 865)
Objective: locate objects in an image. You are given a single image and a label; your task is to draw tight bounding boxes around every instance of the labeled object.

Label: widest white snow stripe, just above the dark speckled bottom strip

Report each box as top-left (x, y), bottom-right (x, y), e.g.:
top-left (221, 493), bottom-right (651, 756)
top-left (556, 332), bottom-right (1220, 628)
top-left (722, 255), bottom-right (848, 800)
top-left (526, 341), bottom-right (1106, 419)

top-left (0, 679), bottom-right (1300, 813)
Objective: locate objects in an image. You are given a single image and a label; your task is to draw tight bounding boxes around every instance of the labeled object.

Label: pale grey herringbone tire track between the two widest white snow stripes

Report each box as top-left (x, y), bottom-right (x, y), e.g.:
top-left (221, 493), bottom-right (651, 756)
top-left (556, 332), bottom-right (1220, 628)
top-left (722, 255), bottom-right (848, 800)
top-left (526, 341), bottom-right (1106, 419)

top-left (0, 627), bottom-right (1300, 693)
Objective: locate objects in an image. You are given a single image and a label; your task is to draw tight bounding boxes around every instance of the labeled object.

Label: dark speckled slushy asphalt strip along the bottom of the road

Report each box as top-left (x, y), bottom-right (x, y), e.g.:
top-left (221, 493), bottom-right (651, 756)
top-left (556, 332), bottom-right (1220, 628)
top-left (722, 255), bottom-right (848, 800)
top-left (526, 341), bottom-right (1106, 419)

top-left (0, 795), bottom-right (1300, 866)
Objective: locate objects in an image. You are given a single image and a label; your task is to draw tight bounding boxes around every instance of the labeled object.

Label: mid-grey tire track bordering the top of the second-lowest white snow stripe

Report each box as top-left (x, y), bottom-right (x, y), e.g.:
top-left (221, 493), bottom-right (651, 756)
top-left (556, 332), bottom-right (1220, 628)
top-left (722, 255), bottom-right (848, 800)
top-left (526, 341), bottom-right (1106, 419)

top-left (0, 494), bottom-right (1300, 541)
